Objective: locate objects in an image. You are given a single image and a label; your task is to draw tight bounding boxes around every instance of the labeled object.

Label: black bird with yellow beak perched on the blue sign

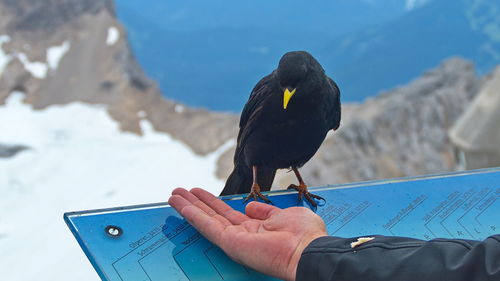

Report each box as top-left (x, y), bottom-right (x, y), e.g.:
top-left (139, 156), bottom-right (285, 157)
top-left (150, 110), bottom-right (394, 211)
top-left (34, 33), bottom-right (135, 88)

top-left (221, 51), bottom-right (340, 206)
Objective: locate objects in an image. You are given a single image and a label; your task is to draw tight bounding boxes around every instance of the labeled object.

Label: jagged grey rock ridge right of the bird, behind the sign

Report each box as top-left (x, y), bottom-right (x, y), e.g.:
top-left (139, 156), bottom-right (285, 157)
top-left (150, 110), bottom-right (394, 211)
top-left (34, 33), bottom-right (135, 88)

top-left (294, 58), bottom-right (481, 185)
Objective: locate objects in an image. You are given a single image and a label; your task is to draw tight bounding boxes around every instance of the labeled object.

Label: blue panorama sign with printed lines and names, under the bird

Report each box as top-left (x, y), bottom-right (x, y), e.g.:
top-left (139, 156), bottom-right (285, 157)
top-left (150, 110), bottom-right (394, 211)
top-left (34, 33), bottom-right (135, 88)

top-left (64, 168), bottom-right (500, 281)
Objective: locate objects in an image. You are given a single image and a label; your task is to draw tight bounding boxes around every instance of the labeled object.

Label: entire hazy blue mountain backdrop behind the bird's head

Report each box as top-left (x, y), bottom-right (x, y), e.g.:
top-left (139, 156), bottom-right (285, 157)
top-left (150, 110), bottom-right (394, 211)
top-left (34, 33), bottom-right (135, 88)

top-left (117, 0), bottom-right (500, 112)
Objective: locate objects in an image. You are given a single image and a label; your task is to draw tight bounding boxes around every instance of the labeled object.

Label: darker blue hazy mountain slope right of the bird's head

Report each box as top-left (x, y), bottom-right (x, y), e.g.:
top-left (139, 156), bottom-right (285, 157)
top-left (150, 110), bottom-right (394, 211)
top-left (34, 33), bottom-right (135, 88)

top-left (328, 0), bottom-right (500, 100)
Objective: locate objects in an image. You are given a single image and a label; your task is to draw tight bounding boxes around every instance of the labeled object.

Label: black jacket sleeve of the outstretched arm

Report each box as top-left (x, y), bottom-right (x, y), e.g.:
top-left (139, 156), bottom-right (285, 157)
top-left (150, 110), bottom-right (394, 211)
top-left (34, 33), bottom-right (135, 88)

top-left (296, 235), bottom-right (500, 281)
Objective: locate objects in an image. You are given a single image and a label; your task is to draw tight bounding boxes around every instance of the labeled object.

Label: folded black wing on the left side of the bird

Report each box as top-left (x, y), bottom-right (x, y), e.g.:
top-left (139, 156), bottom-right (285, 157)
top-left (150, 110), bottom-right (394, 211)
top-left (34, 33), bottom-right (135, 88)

top-left (234, 73), bottom-right (273, 163)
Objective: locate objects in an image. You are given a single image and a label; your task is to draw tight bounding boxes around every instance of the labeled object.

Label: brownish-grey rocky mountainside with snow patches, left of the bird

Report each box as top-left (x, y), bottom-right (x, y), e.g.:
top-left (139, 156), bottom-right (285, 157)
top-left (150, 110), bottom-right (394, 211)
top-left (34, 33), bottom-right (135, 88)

top-left (0, 0), bottom-right (238, 154)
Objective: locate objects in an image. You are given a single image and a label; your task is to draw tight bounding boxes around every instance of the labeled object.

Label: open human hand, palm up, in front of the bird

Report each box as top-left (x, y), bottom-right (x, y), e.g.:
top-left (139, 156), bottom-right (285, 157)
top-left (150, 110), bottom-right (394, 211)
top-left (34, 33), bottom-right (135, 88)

top-left (168, 188), bottom-right (327, 280)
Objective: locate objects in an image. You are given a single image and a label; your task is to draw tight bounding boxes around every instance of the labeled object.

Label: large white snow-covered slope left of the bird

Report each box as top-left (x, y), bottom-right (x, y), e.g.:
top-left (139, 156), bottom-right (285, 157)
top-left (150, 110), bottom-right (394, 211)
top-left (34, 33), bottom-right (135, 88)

top-left (0, 93), bottom-right (232, 281)
